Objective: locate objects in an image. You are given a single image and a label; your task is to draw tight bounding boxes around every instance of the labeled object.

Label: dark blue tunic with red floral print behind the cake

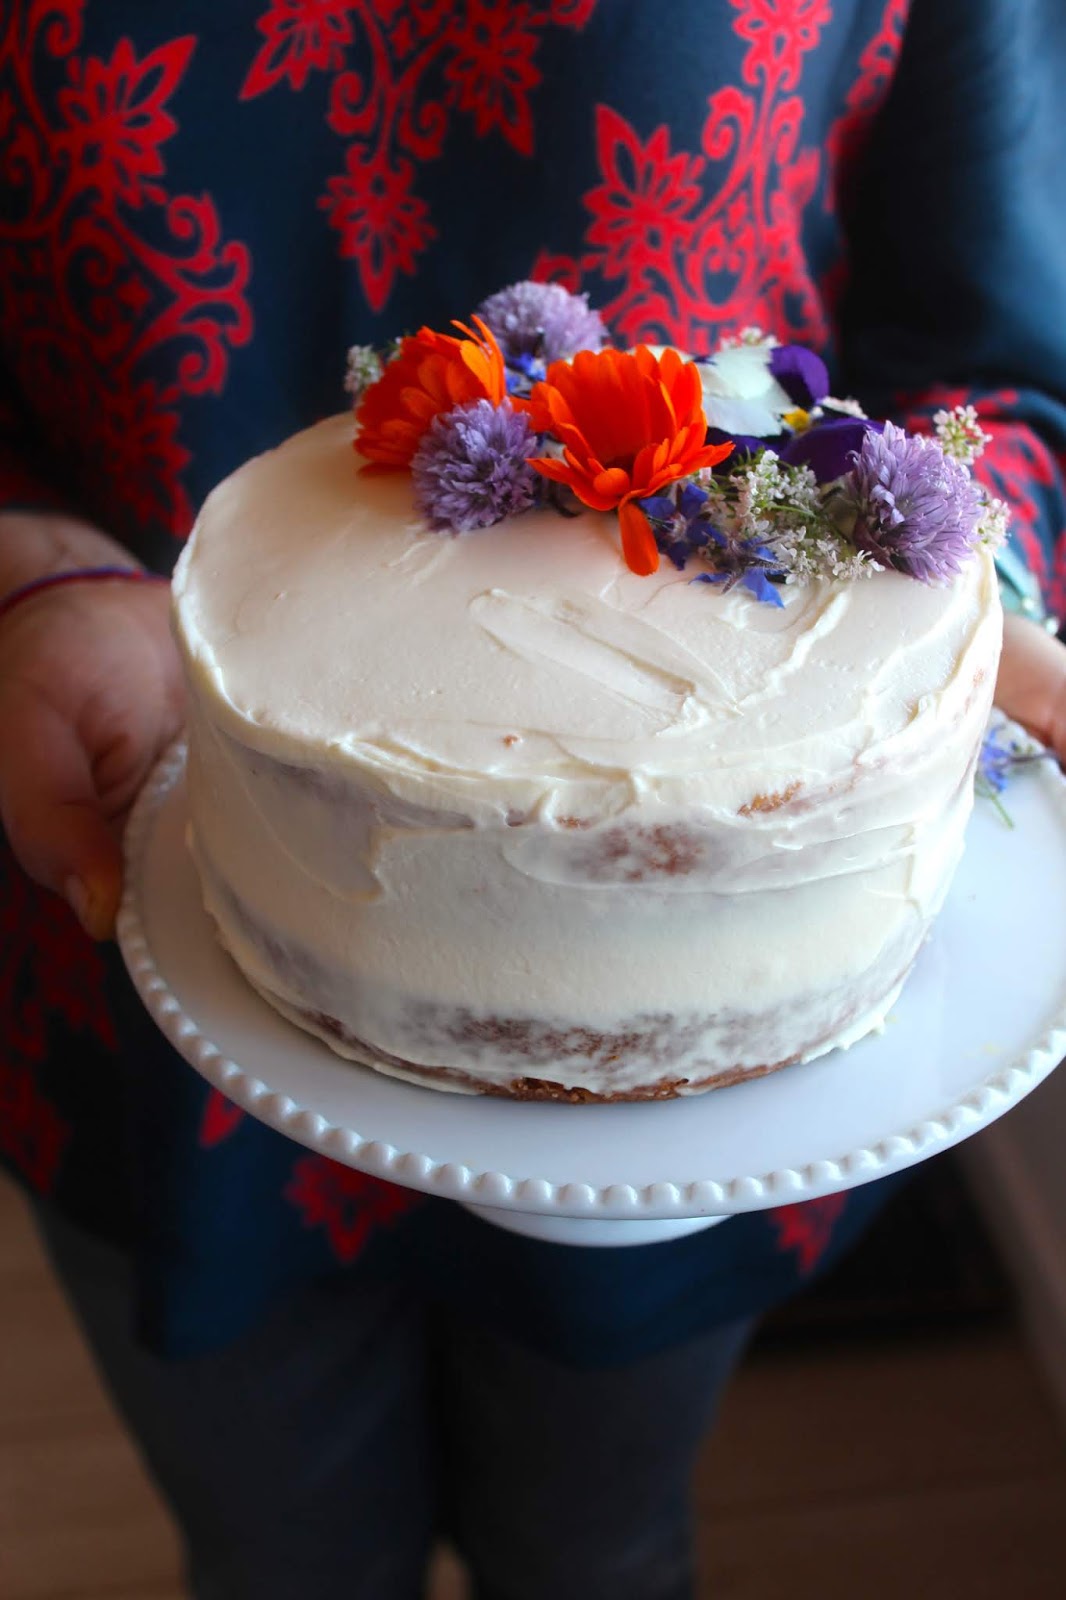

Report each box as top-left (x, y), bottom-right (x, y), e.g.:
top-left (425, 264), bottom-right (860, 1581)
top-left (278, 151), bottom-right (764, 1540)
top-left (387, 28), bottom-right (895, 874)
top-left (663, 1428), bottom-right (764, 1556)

top-left (0, 0), bottom-right (1066, 1362)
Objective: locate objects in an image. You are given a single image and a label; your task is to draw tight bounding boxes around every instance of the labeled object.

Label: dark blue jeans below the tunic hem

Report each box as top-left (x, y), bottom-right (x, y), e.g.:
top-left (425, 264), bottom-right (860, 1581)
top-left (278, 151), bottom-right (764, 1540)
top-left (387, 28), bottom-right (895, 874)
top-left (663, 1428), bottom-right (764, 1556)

top-left (38, 1214), bottom-right (751, 1600)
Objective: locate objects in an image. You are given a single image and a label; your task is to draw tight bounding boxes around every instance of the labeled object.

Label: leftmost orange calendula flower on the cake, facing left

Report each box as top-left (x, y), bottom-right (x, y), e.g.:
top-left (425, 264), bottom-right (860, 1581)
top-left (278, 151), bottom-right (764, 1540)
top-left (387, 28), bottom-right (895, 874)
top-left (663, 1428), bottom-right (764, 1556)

top-left (355, 317), bottom-right (507, 467)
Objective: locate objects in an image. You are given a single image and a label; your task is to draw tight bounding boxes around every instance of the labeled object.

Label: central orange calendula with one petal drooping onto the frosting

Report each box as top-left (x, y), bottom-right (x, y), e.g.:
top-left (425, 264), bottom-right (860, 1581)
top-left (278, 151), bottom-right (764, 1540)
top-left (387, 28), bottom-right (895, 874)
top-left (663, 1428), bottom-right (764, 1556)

top-left (527, 344), bottom-right (733, 576)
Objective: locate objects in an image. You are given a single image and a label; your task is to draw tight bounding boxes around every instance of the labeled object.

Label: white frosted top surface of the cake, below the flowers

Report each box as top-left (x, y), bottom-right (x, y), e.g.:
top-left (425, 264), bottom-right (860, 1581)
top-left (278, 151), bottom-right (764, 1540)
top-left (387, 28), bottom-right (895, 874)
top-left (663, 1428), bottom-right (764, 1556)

top-left (174, 416), bottom-right (999, 806)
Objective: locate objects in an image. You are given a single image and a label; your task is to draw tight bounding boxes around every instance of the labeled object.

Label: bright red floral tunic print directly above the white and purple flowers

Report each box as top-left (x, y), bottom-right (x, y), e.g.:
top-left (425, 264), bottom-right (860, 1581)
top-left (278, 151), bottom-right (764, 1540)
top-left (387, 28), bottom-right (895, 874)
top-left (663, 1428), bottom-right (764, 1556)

top-left (533, 0), bottom-right (892, 355)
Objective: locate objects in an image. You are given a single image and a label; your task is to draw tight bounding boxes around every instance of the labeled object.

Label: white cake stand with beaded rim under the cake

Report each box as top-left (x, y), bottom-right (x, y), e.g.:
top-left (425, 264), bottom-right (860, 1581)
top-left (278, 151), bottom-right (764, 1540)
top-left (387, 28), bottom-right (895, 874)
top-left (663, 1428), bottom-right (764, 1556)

top-left (118, 736), bottom-right (1066, 1245)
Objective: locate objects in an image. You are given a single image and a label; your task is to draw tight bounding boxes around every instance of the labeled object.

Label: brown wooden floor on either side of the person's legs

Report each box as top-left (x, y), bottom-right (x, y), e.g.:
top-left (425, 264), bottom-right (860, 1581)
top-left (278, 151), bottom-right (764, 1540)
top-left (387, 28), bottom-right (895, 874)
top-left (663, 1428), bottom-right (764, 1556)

top-left (0, 1186), bottom-right (1066, 1600)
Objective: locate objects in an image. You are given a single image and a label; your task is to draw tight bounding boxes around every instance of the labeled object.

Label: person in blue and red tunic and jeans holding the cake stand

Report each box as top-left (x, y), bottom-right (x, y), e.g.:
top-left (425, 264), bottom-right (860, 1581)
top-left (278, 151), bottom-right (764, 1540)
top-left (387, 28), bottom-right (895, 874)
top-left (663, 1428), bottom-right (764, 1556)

top-left (0, 0), bottom-right (1066, 1600)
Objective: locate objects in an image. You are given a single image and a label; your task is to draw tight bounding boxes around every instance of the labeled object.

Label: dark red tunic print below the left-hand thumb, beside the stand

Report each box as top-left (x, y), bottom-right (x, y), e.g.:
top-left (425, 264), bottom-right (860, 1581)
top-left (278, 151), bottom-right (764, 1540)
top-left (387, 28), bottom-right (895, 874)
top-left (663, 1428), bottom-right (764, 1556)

top-left (0, 845), bottom-right (115, 1194)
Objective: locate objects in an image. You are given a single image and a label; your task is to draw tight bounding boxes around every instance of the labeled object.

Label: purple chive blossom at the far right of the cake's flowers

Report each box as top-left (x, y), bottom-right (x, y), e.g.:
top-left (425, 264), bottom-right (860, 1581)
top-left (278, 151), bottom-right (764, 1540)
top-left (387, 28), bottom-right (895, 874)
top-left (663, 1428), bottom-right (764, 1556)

top-left (844, 422), bottom-right (981, 584)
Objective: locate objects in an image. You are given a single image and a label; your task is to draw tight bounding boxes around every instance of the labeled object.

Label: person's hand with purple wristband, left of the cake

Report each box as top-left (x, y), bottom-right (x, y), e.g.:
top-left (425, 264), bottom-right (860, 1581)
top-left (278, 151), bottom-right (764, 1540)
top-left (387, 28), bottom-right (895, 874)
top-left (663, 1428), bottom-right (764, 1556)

top-left (0, 515), bottom-right (182, 939)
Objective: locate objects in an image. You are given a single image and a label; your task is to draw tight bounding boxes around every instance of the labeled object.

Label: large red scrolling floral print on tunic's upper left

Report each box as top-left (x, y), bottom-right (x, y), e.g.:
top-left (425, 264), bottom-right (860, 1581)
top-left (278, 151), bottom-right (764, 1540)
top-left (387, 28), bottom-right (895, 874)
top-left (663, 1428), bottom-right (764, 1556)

top-left (0, 0), bottom-right (251, 533)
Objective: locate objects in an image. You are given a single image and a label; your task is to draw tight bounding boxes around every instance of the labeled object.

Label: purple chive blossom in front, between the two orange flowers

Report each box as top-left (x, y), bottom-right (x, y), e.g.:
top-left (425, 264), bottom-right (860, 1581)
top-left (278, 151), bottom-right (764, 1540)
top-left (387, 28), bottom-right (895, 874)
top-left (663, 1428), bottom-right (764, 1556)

top-left (411, 400), bottom-right (538, 533)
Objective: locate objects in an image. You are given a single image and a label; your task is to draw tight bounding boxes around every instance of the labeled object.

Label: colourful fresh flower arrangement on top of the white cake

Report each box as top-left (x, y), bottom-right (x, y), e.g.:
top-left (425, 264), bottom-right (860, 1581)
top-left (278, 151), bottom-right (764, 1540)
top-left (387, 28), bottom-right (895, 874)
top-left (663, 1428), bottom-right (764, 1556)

top-left (346, 283), bottom-right (1007, 605)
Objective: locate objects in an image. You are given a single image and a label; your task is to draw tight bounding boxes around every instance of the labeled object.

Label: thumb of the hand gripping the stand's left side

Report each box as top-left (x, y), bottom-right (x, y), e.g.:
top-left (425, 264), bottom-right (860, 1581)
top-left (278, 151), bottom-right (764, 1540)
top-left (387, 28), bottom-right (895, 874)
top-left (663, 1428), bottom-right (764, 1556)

top-left (0, 693), bottom-right (122, 939)
